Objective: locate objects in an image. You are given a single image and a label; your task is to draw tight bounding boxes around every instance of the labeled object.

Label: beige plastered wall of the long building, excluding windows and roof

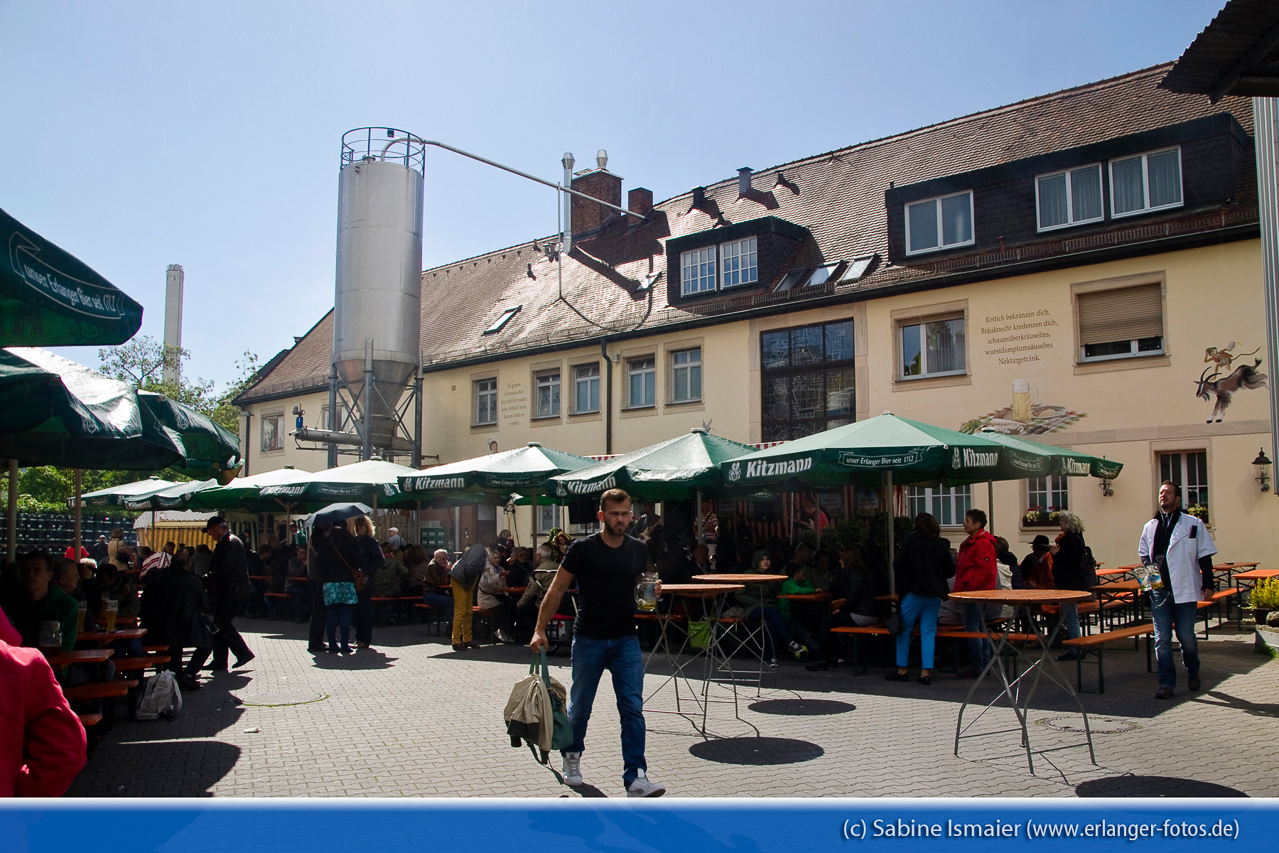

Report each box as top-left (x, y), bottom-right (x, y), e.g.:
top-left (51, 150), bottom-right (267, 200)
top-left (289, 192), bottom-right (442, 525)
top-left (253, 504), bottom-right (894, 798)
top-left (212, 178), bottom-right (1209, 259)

top-left (247, 240), bottom-right (1279, 565)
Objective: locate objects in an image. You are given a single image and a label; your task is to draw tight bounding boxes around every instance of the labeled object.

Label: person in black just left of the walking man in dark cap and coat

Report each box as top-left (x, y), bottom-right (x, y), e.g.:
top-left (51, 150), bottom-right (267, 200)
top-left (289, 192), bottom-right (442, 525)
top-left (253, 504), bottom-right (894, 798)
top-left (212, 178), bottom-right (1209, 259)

top-left (139, 554), bottom-right (214, 691)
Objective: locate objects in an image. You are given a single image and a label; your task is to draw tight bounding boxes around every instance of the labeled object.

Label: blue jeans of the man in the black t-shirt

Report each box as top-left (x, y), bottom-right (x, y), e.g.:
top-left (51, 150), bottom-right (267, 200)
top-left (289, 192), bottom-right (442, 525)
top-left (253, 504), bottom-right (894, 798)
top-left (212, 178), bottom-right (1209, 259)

top-left (560, 634), bottom-right (648, 786)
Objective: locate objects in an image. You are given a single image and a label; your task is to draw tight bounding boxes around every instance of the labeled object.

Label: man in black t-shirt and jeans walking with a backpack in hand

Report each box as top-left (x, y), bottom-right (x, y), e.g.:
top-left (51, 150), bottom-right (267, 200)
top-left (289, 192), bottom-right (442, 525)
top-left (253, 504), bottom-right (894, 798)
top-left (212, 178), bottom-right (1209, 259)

top-left (528, 489), bottom-right (666, 797)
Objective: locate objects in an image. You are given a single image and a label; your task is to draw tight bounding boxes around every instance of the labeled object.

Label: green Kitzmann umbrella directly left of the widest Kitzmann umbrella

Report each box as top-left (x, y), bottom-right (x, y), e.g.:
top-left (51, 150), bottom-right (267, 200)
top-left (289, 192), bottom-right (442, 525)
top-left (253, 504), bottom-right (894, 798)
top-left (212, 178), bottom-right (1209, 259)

top-left (551, 428), bottom-right (756, 500)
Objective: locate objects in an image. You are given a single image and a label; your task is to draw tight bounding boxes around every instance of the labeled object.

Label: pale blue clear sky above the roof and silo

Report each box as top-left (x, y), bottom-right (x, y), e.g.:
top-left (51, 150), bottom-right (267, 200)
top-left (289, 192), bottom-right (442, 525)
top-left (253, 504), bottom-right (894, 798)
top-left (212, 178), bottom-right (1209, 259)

top-left (0, 0), bottom-right (1224, 387)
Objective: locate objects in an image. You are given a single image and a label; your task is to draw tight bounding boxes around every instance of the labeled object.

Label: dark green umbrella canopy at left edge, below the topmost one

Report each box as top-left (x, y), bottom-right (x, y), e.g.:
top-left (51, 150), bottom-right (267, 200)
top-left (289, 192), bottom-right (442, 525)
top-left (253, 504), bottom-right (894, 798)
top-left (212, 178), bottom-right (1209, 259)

top-left (0, 347), bottom-right (240, 477)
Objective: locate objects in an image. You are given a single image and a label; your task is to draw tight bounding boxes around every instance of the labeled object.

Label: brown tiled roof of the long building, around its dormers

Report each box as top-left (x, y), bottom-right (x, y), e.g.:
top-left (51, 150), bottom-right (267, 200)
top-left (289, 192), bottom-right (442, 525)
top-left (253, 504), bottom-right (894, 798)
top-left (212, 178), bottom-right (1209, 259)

top-left (242, 64), bottom-right (1257, 402)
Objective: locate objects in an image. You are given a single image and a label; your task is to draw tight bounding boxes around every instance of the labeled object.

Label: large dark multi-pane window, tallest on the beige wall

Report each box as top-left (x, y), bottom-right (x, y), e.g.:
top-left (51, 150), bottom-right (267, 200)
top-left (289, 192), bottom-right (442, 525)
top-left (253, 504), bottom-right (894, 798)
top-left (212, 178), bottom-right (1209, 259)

top-left (760, 320), bottom-right (857, 441)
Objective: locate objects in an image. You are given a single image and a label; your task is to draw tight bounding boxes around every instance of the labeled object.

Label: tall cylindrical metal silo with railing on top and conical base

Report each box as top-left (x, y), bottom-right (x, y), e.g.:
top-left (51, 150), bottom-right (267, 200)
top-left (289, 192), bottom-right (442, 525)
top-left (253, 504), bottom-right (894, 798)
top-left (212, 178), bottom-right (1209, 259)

top-left (333, 128), bottom-right (425, 455)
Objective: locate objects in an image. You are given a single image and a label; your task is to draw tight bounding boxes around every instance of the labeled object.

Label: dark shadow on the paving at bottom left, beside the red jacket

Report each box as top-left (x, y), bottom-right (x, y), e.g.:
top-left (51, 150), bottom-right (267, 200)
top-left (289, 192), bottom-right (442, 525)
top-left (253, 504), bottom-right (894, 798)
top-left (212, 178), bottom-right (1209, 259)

top-left (68, 740), bottom-right (240, 797)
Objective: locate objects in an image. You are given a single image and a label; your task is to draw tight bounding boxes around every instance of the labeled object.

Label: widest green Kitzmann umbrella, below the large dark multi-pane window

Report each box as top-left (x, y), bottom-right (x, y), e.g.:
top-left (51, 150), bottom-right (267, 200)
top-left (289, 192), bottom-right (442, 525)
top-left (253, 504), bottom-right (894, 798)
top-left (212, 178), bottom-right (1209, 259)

top-left (721, 412), bottom-right (1023, 490)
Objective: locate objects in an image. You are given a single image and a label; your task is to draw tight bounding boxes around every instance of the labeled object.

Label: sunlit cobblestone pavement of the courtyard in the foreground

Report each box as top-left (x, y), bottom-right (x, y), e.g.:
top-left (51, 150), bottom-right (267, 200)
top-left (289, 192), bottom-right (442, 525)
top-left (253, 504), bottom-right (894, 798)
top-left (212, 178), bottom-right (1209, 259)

top-left (70, 620), bottom-right (1279, 797)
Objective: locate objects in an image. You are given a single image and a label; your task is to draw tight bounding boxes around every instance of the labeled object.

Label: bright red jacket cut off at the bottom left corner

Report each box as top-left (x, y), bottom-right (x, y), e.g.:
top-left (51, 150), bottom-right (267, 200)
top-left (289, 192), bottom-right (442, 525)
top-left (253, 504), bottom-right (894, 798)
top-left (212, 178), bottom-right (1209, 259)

top-left (0, 641), bottom-right (86, 797)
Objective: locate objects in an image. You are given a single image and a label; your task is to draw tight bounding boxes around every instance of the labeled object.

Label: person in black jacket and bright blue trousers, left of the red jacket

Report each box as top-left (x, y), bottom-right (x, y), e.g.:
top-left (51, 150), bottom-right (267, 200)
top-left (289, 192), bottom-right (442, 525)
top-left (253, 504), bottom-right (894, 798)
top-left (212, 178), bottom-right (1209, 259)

top-left (884, 513), bottom-right (955, 684)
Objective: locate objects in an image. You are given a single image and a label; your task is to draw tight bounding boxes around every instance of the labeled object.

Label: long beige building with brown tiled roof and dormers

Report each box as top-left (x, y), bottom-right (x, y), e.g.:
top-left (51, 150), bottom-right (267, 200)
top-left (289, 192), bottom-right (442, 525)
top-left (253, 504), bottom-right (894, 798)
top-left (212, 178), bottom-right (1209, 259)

top-left (239, 65), bottom-right (1275, 565)
